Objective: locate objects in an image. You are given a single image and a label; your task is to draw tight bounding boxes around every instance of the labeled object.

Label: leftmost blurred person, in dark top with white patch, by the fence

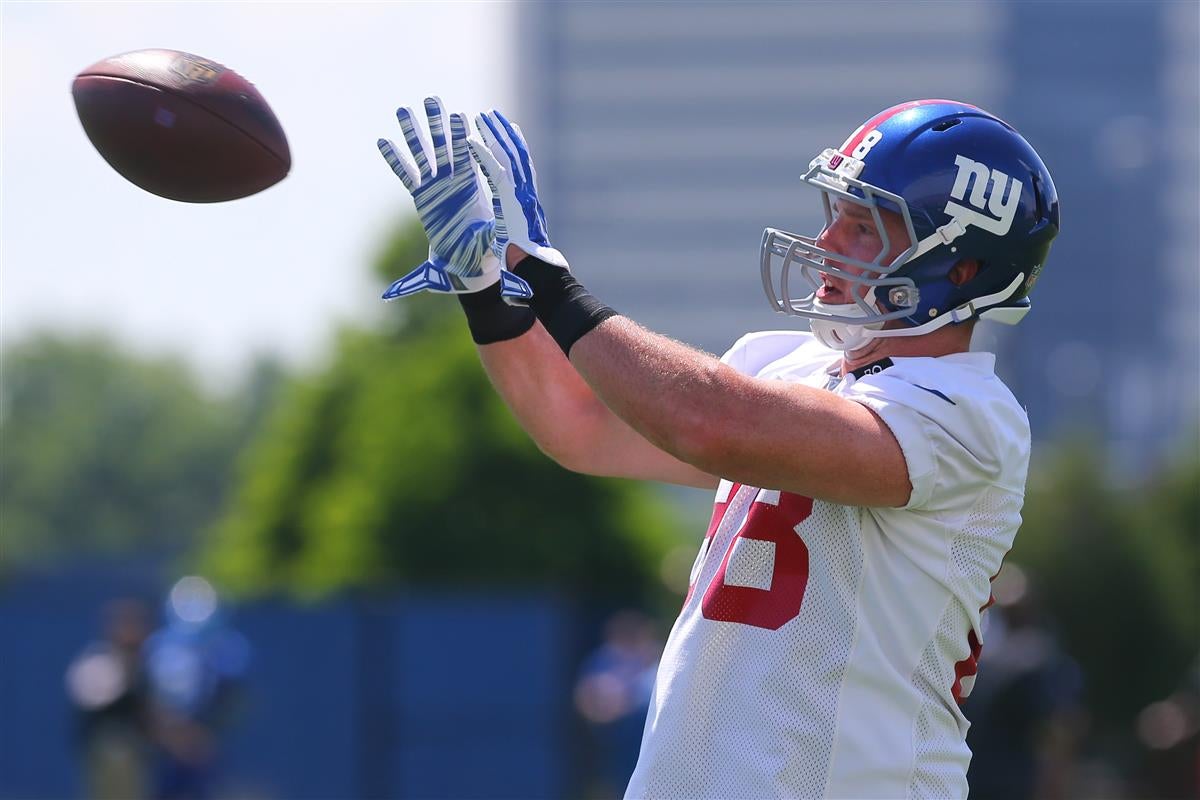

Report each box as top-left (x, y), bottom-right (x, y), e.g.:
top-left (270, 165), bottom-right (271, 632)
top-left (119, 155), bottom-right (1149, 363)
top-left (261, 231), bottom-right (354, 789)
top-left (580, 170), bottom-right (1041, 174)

top-left (66, 599), bottom-right (154, 800)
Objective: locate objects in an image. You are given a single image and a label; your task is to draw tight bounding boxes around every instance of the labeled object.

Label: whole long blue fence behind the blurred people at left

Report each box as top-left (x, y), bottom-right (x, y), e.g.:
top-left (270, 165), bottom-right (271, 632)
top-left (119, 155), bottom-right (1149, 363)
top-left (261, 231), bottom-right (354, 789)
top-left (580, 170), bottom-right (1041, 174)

top-left (0, 573), bottom-right (574, 800)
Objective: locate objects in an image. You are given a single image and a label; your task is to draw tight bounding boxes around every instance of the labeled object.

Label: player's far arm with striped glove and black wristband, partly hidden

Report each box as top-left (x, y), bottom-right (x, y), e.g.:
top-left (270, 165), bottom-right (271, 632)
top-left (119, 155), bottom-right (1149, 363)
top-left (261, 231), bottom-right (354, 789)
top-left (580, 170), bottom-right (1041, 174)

top-left (377, 97), bottom-right (716, 487)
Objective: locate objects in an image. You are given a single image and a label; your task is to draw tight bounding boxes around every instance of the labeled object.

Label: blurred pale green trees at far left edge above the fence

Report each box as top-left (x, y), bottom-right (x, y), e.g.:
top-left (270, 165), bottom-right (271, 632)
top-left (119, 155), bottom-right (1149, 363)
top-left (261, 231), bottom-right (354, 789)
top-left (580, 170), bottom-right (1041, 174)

top-left (0, 335), bottom-right (277, 569)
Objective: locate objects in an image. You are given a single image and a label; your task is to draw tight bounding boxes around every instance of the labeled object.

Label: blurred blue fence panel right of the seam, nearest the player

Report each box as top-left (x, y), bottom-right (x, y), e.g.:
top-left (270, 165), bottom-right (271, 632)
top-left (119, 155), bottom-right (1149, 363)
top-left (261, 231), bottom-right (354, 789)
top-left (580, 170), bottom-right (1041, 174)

top-left (390, 596), bottom-right (570, 799)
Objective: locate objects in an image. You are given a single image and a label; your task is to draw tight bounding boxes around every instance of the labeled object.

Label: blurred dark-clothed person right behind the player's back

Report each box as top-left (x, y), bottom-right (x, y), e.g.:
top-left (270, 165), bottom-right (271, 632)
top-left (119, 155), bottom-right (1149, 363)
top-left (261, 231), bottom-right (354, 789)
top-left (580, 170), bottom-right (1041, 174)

top-left (964, 564), bottom-right (1084, 800)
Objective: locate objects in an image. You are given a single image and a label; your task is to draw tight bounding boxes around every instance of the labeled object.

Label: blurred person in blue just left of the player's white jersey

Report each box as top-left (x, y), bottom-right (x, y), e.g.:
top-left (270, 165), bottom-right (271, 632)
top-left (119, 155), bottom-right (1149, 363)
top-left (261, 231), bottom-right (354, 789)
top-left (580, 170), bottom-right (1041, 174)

top-left (575, 610), bottom-right (662, 798)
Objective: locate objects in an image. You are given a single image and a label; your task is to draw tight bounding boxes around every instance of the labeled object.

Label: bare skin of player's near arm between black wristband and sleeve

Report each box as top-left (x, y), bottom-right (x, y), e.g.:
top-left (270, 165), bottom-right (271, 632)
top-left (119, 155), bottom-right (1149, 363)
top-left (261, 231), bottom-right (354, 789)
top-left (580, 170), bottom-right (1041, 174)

top-left (571, 317), bottom-right (911, 506)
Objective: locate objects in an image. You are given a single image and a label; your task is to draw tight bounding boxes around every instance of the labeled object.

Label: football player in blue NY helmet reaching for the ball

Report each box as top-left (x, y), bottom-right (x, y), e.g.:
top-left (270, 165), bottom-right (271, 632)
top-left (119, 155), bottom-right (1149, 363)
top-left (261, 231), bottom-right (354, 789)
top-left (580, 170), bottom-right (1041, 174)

top-left (379, 98), bottom-right (1058, 799)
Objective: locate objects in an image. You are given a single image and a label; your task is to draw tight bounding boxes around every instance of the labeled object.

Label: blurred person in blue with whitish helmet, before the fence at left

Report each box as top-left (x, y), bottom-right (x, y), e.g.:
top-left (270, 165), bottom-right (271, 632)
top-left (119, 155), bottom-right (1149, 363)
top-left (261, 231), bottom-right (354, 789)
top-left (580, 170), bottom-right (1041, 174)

top-left (145, 576), bottom-right (250, 800)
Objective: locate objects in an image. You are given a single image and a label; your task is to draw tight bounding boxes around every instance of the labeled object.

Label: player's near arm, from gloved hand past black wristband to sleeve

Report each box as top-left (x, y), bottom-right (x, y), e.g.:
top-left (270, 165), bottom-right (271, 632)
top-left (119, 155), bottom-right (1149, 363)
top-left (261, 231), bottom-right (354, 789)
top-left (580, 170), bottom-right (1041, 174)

top-left (468, 112), bottom-right (912, 506)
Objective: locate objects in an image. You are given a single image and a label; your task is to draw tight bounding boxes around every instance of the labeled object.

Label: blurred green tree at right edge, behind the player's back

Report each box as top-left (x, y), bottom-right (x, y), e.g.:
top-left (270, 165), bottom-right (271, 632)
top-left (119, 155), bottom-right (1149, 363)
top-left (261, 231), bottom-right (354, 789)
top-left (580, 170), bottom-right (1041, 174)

top-left (1010, 443), bottom-right (1200, 739)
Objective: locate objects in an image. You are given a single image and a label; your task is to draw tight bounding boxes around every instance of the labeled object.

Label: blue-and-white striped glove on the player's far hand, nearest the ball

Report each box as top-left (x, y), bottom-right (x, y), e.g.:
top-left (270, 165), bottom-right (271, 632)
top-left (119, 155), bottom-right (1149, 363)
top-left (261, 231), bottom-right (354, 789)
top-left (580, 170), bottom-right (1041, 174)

top-left (377, 97), bottom-right (533, 301)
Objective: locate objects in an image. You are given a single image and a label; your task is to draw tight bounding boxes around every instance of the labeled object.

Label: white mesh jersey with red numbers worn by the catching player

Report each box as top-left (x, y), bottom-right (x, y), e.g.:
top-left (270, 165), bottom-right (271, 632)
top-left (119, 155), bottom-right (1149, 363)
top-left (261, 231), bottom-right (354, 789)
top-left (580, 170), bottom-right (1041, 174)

top-left (626, 332), bottom-right (1030, 800)
